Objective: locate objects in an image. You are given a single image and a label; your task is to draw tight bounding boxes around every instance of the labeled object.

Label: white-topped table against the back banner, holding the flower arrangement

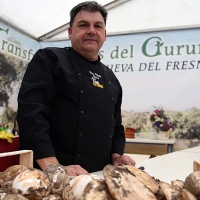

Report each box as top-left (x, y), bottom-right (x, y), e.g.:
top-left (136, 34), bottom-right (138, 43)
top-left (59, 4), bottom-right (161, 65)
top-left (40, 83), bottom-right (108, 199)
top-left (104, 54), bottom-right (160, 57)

top-left (126, 138), bottom-right (176, 153)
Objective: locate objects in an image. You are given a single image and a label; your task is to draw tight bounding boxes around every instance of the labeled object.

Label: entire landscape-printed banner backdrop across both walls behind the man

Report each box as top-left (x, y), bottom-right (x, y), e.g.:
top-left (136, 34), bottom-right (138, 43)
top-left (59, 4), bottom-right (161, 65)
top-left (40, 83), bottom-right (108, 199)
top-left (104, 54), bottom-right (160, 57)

top-left (0, 19), bottom-right (200, 148)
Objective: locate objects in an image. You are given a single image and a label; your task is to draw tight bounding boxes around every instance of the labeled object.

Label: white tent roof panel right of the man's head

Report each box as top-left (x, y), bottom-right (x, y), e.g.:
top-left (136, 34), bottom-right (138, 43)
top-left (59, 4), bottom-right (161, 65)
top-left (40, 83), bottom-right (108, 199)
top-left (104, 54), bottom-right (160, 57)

top-left (107, 0), bottom-right (200, 33)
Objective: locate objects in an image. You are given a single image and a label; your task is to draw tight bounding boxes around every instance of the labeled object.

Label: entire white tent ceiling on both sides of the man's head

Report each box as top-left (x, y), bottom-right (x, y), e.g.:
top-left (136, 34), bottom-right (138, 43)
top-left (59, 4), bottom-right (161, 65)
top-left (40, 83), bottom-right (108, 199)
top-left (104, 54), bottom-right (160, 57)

top-left (0, 0), bottom-right (200, 41)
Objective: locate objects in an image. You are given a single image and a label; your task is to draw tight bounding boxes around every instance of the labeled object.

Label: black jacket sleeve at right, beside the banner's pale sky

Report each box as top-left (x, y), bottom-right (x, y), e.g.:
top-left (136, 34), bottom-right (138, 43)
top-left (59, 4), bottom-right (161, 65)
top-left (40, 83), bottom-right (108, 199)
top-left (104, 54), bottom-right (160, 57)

top-left (111, 76), bottom-right (125, 155)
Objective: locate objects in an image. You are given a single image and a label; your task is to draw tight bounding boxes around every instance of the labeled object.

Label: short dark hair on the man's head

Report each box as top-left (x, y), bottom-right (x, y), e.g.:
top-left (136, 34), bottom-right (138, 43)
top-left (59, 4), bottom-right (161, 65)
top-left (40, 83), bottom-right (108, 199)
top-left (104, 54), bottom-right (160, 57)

top-left (69, 1), bottom-right (108, 26)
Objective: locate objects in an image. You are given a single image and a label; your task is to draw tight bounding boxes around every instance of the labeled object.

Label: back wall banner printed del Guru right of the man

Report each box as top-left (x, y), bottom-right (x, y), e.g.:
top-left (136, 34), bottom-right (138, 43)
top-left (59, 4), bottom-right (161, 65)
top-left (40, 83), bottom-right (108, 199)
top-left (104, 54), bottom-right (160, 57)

top-left (100, 29), bottom-right (200, 146)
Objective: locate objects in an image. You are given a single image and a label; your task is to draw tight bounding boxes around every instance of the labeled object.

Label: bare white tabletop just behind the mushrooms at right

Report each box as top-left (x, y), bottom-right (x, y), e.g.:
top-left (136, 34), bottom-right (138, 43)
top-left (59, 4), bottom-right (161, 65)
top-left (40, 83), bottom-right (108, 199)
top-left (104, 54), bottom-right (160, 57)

top-left (93, 147), bottom-right (200, 183)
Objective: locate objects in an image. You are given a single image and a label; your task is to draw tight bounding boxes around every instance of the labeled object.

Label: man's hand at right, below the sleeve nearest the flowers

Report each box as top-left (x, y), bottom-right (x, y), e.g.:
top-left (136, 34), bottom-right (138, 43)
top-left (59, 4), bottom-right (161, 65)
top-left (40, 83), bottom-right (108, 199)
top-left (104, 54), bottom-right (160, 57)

top-left (112, 153), bottom-right (136, 166)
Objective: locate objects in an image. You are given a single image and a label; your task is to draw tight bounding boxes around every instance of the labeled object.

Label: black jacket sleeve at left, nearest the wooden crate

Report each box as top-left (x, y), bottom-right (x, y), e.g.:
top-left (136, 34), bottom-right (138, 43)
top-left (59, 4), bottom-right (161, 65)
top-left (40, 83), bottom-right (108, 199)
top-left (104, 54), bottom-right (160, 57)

top-left (17, 49), bottom-right (57, 159)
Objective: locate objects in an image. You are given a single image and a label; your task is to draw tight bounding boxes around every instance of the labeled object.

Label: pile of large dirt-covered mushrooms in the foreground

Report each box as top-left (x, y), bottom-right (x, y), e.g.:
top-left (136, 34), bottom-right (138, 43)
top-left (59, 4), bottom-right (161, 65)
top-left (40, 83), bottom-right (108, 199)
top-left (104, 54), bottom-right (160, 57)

top-left (0, 164), bottom-right (200, 200)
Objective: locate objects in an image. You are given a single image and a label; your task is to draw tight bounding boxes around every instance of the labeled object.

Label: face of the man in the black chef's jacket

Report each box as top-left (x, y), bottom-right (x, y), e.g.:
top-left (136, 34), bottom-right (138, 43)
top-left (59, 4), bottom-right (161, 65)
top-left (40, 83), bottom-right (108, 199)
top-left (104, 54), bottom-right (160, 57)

top-left (68, 10), bottom-right (106, 60)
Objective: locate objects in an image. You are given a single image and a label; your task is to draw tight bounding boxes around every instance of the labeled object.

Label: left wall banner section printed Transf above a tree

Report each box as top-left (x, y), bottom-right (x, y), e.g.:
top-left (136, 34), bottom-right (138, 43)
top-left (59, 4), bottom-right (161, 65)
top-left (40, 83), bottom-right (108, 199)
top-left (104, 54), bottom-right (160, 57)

top-left (0, 22), bottom-right (40, 128)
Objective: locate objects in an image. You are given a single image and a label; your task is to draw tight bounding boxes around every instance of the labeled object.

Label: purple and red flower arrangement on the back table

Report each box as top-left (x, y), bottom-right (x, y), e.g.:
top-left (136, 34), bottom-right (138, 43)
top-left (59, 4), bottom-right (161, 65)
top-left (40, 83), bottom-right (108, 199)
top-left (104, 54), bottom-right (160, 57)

top-left (150, 107), bottom-right (177, 133)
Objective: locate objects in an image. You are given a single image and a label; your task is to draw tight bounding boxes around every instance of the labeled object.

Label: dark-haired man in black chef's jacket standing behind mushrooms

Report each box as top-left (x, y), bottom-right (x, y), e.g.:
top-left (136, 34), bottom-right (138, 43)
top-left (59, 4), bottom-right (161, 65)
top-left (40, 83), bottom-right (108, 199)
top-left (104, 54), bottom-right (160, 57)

top-left (17, 1), bottom-right (135, 176)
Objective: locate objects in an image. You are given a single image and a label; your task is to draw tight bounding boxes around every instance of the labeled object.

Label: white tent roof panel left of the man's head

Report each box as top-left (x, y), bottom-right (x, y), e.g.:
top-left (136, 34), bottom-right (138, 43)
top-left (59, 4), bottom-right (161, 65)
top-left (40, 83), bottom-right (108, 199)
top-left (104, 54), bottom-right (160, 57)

top-left (0, 0), bottom-right (113, 39)
